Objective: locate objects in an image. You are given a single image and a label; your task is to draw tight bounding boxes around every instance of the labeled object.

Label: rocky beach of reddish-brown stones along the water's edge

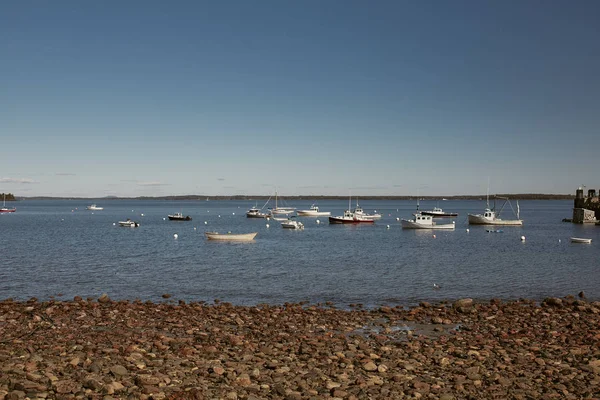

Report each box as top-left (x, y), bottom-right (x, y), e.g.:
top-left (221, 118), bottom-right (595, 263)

top-left (0, 293), bottom-right (600, 400)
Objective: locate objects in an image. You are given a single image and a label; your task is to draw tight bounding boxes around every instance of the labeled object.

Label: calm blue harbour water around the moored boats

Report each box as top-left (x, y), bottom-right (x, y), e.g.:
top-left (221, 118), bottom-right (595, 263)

top-left (0, 200), bottom-right (600, 306)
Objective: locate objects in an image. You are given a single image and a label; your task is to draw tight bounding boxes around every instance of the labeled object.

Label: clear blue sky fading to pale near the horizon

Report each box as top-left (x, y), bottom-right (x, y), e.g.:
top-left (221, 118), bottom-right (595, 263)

top-left (0, 0), bottom-right (600, 197)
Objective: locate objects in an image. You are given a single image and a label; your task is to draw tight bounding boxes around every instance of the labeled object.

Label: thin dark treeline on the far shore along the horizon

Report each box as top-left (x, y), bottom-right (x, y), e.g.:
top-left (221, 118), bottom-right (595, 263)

top-left (22, 193), bottom-right (575, 201)
